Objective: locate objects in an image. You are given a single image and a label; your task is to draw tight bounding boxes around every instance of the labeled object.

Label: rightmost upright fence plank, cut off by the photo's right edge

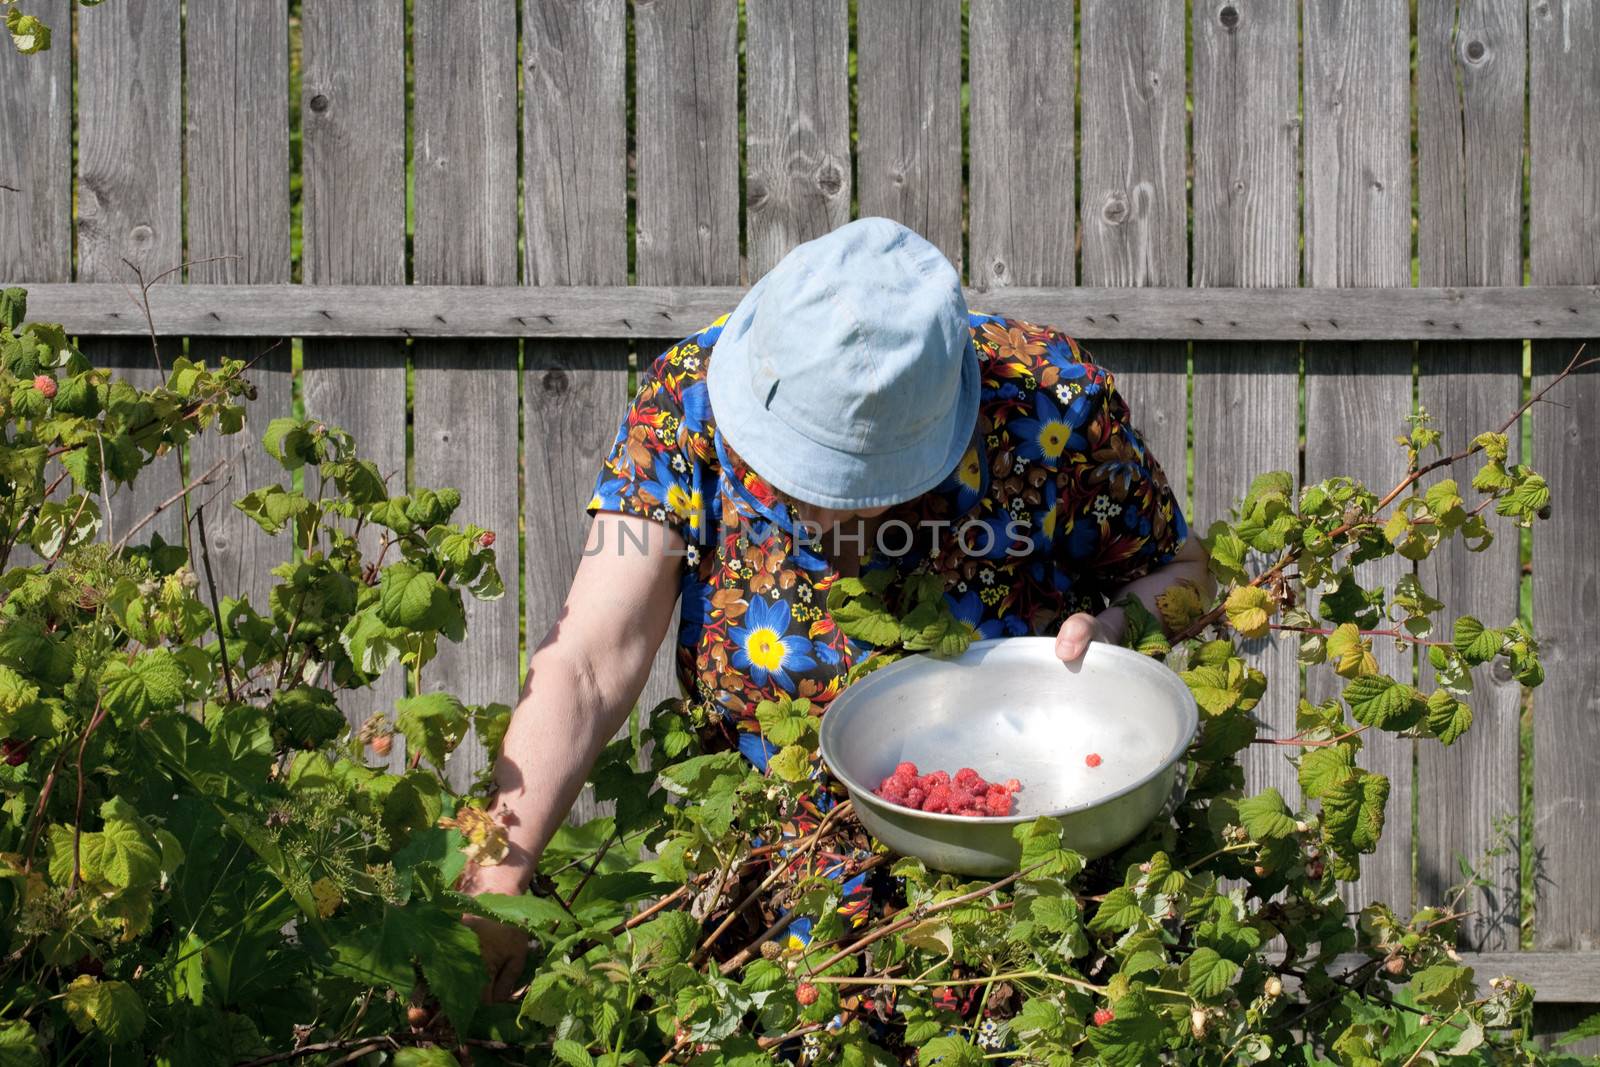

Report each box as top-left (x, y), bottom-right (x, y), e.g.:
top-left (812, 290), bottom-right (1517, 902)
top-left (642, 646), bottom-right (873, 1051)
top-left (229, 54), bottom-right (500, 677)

top-left (1528, 0), bottom-right (1600, 1051)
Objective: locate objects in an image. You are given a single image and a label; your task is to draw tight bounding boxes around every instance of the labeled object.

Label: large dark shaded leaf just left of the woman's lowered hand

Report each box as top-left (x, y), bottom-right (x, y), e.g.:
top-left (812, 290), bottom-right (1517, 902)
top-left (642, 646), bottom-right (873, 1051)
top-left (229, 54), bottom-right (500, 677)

top-left (333, 901), bottom-right (488, 1032)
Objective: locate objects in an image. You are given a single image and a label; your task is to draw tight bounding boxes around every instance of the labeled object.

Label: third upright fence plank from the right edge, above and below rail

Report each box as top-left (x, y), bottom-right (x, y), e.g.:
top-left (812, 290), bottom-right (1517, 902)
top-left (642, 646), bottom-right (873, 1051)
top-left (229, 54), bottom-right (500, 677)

top-left (1301, 0), bottom-right (1414, 910)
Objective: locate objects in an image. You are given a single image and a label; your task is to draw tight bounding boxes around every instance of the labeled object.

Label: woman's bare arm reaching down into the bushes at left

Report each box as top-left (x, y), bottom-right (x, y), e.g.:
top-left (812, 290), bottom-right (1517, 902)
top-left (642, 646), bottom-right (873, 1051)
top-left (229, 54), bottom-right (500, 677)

top-left (461, 512), bottom-right (685, 998)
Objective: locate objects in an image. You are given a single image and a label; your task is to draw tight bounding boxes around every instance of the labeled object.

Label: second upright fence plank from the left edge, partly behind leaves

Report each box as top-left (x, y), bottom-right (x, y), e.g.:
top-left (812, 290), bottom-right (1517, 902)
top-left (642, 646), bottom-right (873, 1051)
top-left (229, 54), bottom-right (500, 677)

top-left (75, 0), bottom-right (184, 542)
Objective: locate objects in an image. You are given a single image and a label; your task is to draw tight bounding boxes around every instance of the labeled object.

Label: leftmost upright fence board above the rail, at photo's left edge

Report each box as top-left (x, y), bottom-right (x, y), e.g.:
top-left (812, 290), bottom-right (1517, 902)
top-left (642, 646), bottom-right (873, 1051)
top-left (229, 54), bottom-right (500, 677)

top-left (0, 0), bottom-right (75, 282)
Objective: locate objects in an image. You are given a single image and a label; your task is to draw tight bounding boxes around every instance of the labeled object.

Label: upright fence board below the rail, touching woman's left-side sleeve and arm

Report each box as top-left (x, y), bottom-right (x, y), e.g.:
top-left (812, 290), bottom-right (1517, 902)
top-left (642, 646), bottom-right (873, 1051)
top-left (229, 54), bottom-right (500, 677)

top-left (522, 341), bottom-right (627, 822)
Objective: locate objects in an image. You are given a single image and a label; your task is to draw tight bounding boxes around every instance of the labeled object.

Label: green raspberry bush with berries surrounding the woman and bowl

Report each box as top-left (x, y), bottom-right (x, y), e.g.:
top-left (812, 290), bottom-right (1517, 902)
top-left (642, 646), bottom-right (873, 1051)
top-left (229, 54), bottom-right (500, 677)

top-left (0, 290), bottom-right (1600, 1067)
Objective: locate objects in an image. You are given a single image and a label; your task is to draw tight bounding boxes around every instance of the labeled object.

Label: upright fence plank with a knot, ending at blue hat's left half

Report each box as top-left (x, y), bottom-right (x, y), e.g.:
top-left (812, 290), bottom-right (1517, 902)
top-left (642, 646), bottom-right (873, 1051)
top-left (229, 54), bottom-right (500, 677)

top-left (744, 0), bottom-right (851, 282)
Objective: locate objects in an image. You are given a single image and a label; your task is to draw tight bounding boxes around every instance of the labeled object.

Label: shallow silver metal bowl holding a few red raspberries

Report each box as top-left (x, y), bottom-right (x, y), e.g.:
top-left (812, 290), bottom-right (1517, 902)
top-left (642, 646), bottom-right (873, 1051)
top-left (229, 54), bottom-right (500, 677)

top-left (821, 637), bottom-right (1198, 875)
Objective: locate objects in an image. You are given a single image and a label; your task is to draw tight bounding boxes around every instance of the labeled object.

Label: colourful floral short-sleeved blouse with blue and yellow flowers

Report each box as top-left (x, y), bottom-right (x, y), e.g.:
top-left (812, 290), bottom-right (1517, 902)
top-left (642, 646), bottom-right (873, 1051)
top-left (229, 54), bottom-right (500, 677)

top-left (589, 314), bottom-right (1187, 763)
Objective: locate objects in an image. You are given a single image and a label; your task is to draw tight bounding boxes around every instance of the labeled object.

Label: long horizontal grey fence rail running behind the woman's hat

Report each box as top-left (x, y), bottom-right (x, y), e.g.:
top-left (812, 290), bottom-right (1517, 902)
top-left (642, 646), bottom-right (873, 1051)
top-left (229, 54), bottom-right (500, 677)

top-left (25, 278), bottom-right (1600, 342)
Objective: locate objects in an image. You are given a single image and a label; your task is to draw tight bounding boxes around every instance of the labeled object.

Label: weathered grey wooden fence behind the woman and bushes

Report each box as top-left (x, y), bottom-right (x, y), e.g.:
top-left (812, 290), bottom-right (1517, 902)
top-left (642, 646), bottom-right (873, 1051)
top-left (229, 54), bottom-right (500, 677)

top-left (0, 0), bottom-right (1600, 1025)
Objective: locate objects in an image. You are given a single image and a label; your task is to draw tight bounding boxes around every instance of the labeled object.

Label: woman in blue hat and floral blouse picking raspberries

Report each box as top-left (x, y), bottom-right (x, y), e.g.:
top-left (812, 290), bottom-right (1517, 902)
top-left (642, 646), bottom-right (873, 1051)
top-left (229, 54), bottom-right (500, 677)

top-left (464, 219), bottom-right (1208, 995)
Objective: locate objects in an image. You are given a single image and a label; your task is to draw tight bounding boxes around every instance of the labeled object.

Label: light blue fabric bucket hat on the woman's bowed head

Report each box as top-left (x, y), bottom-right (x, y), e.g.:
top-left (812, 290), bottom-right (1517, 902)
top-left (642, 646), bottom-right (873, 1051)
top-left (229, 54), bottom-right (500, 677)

top-left (706, 219), bottom-right (979, 510)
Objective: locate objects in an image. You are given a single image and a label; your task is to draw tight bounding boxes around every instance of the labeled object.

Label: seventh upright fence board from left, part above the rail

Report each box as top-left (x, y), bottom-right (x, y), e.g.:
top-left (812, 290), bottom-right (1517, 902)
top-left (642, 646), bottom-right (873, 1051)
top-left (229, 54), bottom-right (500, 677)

top-left (634, 0), bottom-right (741, 287)
